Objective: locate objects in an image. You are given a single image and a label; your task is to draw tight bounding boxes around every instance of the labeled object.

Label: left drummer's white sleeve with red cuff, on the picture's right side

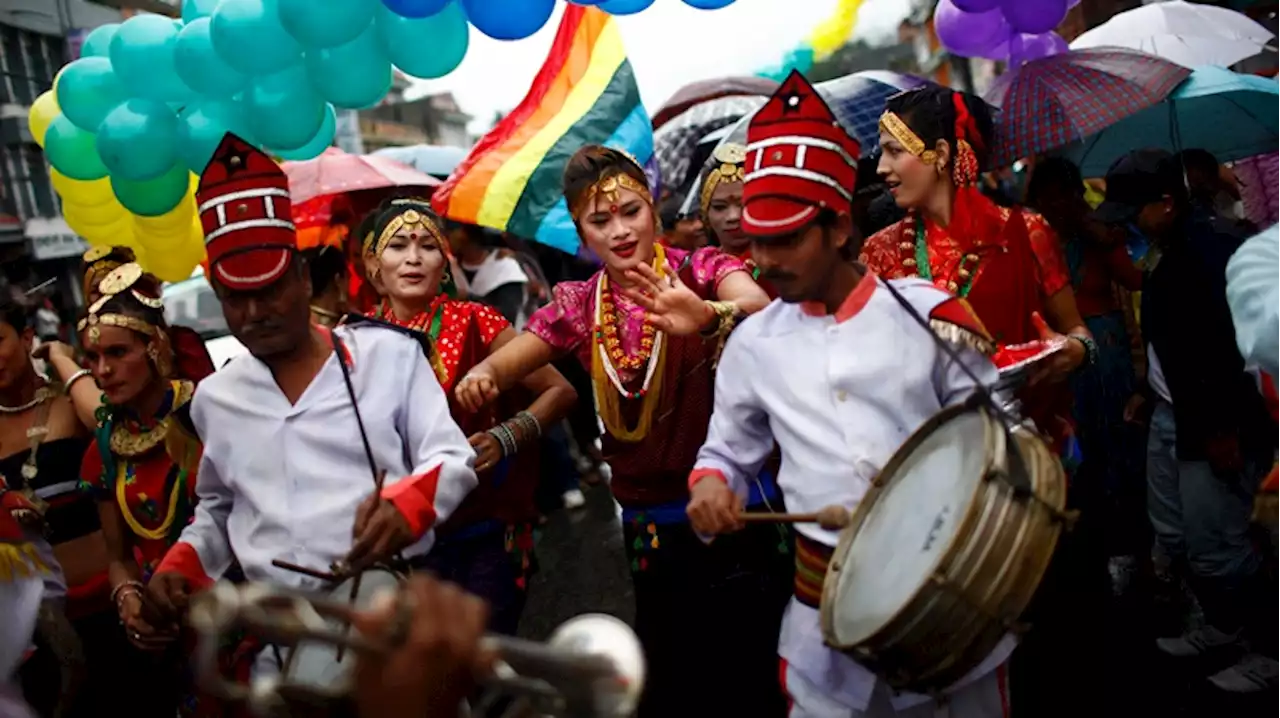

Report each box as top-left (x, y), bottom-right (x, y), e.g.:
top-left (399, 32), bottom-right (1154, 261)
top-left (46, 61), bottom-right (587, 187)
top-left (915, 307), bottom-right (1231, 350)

top-left (383, 343), bottom-right (477, 538)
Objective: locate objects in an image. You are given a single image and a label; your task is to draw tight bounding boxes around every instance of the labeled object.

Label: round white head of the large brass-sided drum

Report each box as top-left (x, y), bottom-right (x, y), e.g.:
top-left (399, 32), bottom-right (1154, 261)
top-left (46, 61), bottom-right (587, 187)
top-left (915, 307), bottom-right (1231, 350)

top-left (823, 411), bottom-right (989, 648)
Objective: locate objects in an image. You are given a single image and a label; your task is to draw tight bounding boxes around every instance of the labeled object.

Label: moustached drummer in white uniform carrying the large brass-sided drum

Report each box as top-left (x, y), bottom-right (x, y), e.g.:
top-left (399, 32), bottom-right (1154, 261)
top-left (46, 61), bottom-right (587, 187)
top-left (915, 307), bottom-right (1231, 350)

top-left (689, 73), bottom-right (1014, 718)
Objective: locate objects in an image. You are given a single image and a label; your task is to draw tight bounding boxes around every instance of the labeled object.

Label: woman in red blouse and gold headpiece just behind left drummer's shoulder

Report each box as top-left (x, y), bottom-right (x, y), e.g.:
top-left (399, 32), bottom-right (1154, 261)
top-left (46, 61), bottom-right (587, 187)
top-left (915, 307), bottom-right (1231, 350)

top-left (364, 198), bottom-right (577, 634)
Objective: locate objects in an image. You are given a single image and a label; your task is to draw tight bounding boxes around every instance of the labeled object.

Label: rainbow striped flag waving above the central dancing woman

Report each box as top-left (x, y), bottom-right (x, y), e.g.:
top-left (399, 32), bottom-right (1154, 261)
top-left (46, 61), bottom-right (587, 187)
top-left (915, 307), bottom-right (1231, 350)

top-left (431, 4), bottom-right (653, 253)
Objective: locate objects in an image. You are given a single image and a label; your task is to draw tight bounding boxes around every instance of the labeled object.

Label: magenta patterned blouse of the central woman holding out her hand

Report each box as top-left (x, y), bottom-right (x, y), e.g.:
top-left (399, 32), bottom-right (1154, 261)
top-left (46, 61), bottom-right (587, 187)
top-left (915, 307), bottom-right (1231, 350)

top-left (525, 247), bottom-right (746, 381)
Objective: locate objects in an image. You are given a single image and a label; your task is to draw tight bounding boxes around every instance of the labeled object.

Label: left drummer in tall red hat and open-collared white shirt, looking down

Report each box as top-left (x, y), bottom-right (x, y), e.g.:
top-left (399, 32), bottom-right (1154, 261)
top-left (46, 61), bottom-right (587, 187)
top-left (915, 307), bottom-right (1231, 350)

top-left (141, 134), bottom-right (476, 673)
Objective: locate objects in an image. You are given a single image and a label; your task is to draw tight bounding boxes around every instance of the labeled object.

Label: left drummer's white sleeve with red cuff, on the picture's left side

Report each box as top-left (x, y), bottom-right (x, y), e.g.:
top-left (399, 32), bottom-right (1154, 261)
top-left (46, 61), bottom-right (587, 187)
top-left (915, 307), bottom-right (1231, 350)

top-left (155, 392), bottom-right (236, 585)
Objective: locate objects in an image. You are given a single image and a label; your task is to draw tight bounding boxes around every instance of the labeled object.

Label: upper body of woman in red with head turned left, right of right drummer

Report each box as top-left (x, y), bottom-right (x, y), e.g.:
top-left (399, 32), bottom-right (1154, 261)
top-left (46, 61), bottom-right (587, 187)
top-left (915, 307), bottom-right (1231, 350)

top-left (861, 87), bottom-right (1097, 457)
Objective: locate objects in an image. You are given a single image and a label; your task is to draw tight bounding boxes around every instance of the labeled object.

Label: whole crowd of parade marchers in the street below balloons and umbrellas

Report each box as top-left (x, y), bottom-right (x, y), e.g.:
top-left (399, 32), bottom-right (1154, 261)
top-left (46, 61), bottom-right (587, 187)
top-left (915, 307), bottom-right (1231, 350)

top-left (0, 68), bottom-right (1280, 718)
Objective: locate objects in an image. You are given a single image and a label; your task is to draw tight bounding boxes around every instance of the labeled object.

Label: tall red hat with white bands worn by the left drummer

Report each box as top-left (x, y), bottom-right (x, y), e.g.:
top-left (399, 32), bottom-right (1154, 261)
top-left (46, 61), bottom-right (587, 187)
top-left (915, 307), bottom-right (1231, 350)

top-left (196, 134), bottom-right (297, 289)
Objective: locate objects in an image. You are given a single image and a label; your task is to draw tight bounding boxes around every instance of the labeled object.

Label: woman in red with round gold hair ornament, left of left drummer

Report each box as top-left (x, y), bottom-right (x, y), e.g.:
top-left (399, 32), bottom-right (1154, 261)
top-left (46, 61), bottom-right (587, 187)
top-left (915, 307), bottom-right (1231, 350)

top-left (78, 262), bottom-right (212, 717)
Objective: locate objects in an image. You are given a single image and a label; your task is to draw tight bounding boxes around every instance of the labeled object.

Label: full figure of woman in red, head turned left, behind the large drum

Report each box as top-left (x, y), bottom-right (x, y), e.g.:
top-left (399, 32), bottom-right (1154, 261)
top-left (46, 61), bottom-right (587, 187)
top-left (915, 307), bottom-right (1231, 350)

top-left (861, 86), bottom-right (1108, 718)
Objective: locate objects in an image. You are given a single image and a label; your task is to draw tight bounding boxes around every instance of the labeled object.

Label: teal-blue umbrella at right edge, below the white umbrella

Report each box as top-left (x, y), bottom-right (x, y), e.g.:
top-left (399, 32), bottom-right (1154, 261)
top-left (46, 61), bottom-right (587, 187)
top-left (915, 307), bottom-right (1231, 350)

top-left (1062, 67), bottom-right (1280, 177)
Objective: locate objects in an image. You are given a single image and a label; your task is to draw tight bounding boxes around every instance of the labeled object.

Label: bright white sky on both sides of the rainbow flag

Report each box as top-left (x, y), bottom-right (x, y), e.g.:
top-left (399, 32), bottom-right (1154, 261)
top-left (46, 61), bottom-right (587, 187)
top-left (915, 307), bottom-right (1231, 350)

top-left (411, 0), bottom-right (911, 132)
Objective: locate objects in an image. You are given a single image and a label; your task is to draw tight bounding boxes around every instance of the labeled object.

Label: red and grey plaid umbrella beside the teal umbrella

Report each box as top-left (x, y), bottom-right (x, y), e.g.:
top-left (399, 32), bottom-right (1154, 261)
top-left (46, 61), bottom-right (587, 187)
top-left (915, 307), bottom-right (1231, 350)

top-left (986, 47), bottom-right (1190, 166)
